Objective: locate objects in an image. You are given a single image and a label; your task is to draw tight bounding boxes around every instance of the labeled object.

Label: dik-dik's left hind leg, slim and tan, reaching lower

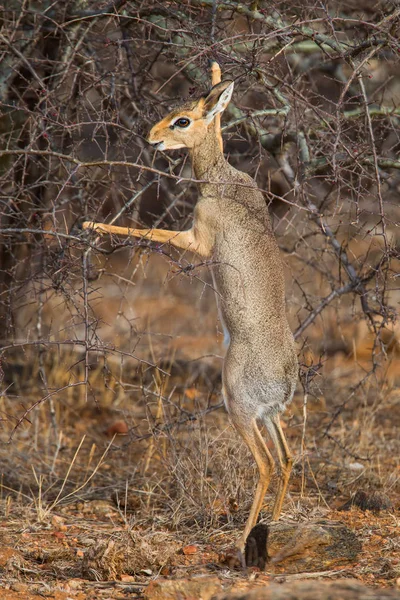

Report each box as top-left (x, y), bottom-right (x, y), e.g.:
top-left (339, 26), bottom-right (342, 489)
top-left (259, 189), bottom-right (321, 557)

top-left (231, 414), bottom-right (274, 553)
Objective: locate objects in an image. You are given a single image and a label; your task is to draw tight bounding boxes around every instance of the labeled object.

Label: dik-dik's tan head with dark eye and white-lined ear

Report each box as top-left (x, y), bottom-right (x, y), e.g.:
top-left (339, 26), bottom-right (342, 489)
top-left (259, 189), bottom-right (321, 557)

top-left (148, 81), bottom-right (233, 150)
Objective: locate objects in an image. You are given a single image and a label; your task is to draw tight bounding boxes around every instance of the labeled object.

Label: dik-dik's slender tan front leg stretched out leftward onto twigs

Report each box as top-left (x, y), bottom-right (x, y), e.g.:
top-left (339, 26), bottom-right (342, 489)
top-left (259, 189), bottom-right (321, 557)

top-left (82, 221), bottom-right (212, 258)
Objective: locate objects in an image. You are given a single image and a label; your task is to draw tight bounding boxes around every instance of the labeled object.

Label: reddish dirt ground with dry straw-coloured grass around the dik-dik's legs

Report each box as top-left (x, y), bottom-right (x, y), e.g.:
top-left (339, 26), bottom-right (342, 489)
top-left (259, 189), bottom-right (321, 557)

top-left (0, 251), bottom-right (400, 600)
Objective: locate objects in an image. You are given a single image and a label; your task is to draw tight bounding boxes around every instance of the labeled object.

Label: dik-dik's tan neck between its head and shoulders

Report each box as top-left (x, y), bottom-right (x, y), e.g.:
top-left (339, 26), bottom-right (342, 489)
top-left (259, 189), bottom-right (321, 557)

top-left (190, 123), bottom-right (229, 192)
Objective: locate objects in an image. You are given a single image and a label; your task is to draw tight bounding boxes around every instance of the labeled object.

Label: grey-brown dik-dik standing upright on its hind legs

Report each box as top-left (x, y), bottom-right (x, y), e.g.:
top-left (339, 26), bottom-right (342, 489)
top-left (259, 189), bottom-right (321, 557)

top-left (84, 70), bottom-right (297, 552)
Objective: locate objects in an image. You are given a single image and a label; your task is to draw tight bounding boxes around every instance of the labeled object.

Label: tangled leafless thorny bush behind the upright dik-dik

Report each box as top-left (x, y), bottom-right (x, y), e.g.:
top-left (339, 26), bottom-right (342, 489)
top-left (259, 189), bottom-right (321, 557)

top-left (0, 0), bottom-right (400, 502)
